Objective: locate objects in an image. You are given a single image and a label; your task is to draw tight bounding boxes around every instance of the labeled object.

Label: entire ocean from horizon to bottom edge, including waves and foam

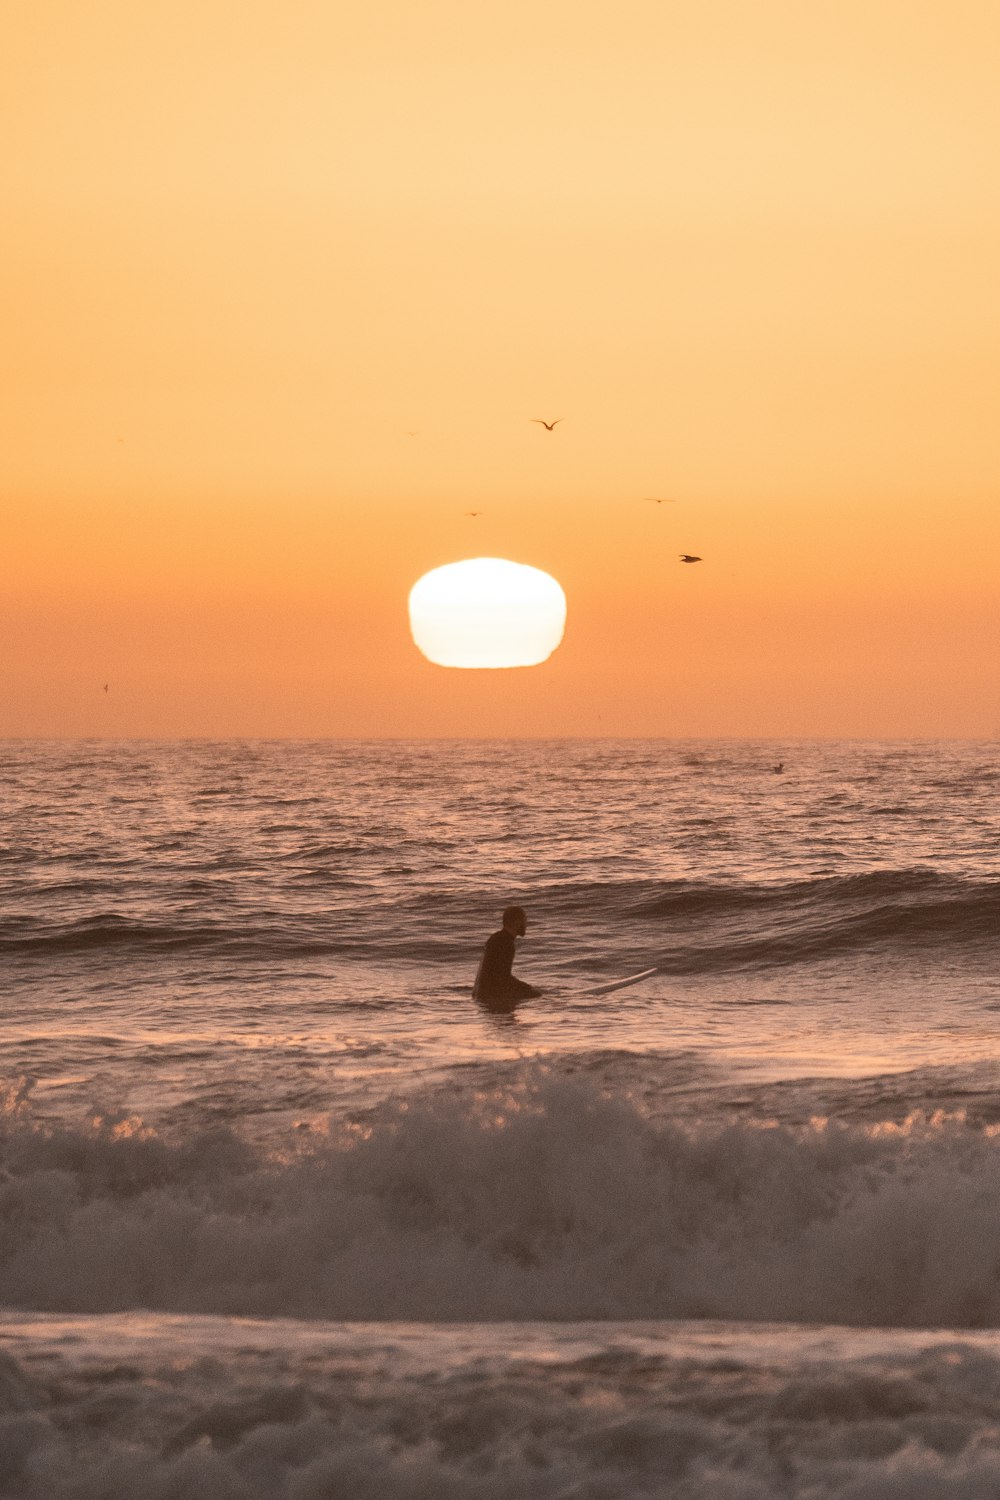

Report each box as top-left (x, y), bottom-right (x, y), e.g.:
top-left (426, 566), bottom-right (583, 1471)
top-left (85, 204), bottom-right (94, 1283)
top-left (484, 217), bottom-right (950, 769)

top-left (0, 740), bottom-right (1000, 1500)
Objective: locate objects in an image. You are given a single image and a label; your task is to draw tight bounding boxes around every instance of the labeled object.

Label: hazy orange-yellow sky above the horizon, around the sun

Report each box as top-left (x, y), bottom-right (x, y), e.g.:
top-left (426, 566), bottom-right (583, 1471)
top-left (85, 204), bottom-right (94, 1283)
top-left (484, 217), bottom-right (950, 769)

top-left (0, 0), bottom-right (1000, 737)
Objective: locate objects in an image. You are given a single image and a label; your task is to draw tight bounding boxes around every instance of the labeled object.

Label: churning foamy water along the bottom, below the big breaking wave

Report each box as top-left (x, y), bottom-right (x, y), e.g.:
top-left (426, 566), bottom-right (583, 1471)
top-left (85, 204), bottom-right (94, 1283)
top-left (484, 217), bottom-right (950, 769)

top-left (0, 1316), bottom-right (1000, 1500)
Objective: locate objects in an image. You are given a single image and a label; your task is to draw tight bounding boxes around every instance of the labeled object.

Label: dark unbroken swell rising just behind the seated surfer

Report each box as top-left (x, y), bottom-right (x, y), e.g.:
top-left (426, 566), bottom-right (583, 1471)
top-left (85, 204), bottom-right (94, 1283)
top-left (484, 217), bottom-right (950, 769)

top-left (0, 870), bottom-right (1000, 974)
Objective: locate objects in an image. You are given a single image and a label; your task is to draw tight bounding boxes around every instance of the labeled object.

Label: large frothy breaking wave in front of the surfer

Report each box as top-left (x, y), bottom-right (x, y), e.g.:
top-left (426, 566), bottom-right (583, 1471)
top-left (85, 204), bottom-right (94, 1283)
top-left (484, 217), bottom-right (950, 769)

top-left (0, 1064), bottom-right (1000, 1328)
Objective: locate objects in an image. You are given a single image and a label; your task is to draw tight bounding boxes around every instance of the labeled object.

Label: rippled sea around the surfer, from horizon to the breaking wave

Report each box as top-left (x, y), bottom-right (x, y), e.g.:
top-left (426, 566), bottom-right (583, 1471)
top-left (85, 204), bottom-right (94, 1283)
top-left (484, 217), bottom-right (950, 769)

top-left (0, 741), bottom-right (1000, 1121)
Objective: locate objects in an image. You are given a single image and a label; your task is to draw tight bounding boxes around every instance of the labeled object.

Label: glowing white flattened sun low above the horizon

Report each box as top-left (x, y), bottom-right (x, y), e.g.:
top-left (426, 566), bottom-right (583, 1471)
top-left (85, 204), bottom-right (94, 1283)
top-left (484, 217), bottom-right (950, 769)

top-left (409, 558), bottom-right (565, 668)
